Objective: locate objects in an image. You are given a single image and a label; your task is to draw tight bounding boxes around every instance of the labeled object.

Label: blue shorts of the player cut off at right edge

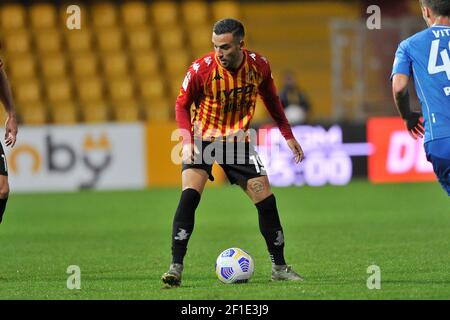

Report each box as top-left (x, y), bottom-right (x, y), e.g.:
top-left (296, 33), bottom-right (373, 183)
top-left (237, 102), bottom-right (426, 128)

top-left (425, 138), bottom-right (450, 196)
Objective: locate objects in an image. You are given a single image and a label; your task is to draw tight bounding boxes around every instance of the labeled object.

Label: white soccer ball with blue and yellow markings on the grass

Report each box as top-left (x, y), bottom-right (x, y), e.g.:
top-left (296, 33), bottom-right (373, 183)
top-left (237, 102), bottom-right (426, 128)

top-left (215, 248), bottom-right (255, 283)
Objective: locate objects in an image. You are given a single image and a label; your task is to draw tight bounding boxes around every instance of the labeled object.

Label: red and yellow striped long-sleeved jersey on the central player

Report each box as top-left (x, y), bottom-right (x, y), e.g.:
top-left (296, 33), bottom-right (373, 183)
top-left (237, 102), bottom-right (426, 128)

top-left (176, 50), bottom-right (293, 143)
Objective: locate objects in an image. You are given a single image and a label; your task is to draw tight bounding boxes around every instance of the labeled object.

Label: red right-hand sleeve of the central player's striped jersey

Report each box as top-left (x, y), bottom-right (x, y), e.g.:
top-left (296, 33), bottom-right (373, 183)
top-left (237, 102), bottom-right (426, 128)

top-left (258, 58), bottom-right (294, 140)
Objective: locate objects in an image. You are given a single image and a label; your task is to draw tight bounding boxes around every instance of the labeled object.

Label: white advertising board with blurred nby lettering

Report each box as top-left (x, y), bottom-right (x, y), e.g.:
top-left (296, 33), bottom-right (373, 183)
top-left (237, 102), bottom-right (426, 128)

top-left (6, 123), bottom-right (147, 192)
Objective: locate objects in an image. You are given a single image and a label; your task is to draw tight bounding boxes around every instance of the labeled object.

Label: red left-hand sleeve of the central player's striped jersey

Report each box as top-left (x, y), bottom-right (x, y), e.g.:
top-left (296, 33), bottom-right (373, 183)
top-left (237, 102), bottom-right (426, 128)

top-left (175, 63), bottom-right (202, 144)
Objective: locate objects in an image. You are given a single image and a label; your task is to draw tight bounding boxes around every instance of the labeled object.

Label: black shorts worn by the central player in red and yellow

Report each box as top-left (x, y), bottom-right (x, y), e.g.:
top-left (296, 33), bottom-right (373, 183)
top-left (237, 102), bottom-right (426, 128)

top-left (182, 141), bottom-right (267, 188)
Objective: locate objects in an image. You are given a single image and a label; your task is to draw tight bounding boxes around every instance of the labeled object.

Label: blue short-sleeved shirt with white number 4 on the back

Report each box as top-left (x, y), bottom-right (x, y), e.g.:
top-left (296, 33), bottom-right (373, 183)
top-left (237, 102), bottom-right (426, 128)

top-left (391, 25), bottom-right (450, 142)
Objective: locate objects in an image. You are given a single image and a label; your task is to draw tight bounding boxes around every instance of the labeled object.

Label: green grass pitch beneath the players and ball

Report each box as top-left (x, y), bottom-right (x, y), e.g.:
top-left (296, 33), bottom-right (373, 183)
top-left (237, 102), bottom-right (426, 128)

top-left (0, 181), bottom-right (450, 299)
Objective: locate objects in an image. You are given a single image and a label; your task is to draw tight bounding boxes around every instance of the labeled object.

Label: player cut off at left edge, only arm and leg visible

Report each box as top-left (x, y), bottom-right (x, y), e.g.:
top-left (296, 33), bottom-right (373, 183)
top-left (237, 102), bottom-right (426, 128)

top-left (0, 60), bottom-right (17, 223)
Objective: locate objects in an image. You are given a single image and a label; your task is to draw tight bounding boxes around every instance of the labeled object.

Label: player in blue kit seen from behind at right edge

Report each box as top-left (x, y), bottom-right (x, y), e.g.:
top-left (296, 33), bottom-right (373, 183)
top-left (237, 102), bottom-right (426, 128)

top-left (392, 0), bottom-right (450, 196)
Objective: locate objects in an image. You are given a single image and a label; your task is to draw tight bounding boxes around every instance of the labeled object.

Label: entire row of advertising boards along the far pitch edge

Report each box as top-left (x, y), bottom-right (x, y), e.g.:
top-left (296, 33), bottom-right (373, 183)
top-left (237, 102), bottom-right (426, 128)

top-left (5, 118), bottom-right (435, 192)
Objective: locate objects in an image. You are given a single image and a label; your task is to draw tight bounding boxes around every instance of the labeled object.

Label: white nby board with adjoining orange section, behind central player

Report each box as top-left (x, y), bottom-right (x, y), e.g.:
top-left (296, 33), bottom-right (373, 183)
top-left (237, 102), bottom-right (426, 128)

top-left (5, 122), bottom-right (225, 192)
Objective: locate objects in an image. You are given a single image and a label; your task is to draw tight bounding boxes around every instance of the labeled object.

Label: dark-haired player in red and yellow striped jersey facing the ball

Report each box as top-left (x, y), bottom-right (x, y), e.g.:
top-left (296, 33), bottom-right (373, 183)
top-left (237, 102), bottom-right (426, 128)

top-left (162, 19), bottom-right (304, 287)
